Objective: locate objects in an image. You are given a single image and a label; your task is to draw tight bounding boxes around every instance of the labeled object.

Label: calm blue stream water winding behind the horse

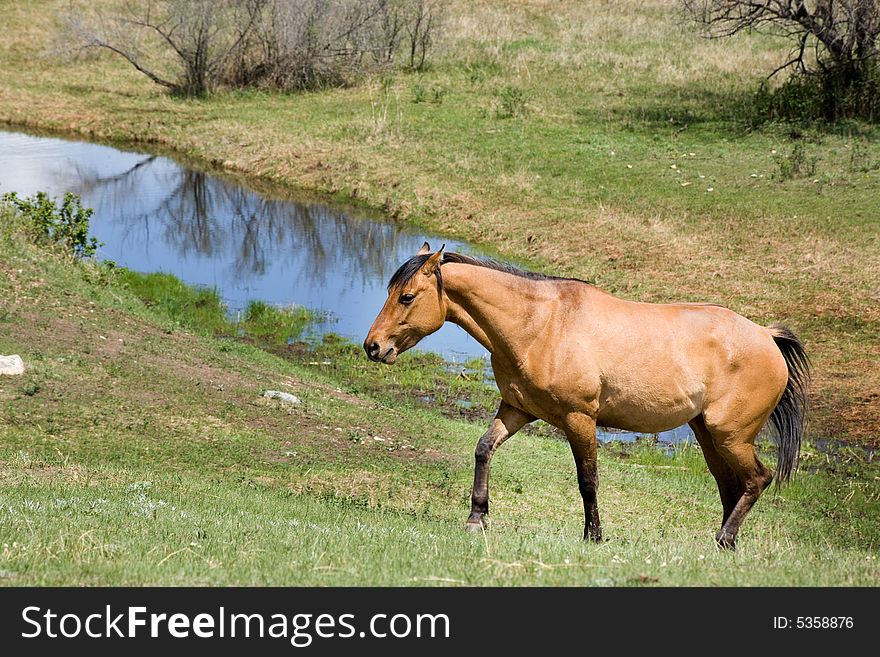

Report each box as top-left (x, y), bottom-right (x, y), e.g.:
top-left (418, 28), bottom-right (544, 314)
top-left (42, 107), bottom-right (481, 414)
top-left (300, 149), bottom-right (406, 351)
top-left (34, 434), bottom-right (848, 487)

top-left (0, 131), bottom-right (693, 443)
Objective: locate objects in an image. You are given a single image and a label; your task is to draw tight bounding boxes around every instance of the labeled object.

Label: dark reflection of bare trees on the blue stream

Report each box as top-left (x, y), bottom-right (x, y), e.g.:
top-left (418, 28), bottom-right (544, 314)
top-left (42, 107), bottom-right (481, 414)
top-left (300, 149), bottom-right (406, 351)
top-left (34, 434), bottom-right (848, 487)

top-left (78, 156), bottom-right (418, 286)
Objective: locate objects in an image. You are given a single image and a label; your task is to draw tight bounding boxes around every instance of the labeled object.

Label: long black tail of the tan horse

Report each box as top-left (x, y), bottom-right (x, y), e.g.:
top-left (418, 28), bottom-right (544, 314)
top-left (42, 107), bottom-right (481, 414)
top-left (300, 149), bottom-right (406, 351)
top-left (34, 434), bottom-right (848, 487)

top-left (768, 324), bottom-right (810, 485)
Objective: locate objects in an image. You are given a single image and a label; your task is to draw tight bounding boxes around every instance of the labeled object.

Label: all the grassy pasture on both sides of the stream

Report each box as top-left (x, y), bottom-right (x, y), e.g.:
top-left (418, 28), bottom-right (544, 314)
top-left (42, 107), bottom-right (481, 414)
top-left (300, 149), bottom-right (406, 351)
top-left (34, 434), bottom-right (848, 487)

top-left (0, 0), bottom-right (880, 586)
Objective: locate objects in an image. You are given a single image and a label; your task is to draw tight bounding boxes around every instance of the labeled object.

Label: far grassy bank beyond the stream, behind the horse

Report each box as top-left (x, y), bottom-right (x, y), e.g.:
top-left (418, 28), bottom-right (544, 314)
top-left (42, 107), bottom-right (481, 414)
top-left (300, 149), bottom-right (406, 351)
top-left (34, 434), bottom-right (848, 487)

top-left (0, 0), bottom-right (880, 445)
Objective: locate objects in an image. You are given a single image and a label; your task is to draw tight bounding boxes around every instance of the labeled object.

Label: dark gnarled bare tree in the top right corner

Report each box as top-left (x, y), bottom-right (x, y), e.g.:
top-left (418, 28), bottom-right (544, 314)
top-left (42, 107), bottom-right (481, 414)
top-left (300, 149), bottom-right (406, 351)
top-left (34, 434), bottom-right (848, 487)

top-left (683, 0), bottom-right (880, 119)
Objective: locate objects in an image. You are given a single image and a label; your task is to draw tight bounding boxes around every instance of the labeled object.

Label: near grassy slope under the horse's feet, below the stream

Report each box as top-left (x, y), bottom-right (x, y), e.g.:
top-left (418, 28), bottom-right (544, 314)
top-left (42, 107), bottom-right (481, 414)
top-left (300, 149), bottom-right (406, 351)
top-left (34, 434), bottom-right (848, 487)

top-left (0, 195), bottom-right (880, 586)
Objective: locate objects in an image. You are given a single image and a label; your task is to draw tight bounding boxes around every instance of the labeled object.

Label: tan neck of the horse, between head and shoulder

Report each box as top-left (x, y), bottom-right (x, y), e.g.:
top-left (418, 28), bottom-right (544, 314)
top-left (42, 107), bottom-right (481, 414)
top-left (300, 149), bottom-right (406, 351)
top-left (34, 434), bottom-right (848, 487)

top-left (443, 263), bottom-right (550, 360)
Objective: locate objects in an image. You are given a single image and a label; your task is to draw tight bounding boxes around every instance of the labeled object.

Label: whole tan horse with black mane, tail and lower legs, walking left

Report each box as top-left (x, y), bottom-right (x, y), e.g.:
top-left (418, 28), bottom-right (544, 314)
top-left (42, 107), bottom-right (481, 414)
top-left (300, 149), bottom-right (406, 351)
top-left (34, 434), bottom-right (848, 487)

top-left (364, 242), bottom-right (809, 548)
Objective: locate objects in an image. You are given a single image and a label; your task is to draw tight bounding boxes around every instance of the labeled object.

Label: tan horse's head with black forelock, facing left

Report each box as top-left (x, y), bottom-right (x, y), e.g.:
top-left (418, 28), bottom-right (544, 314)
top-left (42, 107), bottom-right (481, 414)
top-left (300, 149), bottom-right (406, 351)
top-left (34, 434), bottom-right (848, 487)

top-left (364, 242), bottom-right (446, 365)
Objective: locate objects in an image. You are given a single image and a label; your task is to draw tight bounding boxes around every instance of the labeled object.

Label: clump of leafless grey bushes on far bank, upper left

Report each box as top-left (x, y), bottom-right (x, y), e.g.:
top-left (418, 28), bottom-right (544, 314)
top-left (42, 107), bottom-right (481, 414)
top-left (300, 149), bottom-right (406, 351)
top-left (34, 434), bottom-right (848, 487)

top-left (66, 0), bottom-right (444, 96)
